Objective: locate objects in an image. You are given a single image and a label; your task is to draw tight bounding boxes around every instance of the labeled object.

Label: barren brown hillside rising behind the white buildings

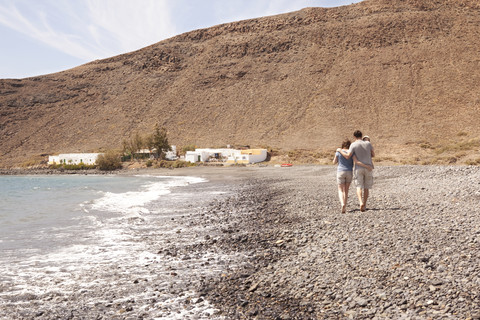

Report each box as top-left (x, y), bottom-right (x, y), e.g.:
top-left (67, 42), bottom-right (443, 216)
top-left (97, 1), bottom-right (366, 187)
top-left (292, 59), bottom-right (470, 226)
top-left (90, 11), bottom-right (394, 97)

top-left (0, 0), bottom-right (480, 166)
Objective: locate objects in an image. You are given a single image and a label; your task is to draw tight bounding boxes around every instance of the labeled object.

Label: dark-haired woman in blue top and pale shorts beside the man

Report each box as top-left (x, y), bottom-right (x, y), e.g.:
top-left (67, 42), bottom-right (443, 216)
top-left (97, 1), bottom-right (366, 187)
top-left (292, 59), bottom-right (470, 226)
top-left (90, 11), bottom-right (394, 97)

top-left (333, 139), bottom-right (354, 213)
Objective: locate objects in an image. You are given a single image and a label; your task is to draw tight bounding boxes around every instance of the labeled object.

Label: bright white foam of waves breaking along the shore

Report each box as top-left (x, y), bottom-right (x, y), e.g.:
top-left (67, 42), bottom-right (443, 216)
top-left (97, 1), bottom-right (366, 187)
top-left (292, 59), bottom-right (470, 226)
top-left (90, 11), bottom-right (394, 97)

top-left (0, 177), bottom-right (221, 319)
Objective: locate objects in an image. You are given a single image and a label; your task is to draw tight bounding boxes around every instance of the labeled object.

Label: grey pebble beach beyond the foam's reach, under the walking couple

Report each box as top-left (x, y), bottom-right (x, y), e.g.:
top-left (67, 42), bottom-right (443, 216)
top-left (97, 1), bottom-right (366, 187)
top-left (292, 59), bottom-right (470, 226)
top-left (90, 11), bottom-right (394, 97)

top-left (195, 166), bottom-right (480, 319)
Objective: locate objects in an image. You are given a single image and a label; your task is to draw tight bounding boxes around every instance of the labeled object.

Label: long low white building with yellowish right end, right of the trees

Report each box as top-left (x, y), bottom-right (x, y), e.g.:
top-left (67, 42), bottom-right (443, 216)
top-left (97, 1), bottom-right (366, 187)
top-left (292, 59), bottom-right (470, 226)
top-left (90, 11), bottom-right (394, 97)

top-left (185, 148), bottom-right (267, 164)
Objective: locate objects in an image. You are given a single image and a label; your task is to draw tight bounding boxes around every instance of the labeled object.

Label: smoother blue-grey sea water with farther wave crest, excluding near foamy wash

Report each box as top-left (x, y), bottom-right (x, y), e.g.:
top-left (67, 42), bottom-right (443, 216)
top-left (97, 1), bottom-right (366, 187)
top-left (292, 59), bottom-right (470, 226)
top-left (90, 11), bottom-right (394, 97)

top-left (0, 175), bottom-right (203, 259)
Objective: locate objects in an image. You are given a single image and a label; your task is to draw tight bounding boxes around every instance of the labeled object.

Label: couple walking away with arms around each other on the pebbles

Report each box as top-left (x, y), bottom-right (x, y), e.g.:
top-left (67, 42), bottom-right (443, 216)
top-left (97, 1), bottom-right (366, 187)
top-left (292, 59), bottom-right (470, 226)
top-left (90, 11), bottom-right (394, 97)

top-left (333, 130), bottom-right (375, 213)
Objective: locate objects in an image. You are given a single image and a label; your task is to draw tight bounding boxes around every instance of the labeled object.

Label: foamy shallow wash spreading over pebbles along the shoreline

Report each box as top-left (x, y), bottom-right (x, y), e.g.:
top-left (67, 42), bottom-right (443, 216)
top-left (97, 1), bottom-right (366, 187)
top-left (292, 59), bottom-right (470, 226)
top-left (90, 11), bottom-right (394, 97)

top-left (0, 171), bottom-right (251, 319)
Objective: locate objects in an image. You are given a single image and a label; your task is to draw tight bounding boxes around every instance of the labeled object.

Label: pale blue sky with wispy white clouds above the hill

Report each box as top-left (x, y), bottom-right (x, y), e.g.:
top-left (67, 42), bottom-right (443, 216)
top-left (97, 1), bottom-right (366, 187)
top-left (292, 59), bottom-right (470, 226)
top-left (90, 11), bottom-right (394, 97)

top-left (0, 0), bottom-right (360, 79)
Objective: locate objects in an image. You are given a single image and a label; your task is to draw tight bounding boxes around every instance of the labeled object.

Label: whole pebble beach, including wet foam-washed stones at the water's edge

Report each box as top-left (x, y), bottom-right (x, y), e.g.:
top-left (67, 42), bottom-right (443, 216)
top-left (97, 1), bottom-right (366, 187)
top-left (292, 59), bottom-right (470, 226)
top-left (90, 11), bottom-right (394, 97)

top-left (0, 166), bottom-right (480, 319)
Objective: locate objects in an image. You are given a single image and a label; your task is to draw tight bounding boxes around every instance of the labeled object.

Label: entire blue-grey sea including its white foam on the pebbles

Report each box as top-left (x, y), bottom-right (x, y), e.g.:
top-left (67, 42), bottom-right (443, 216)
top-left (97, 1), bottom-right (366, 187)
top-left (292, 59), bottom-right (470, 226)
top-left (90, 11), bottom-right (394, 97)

top-left (0, 175), bottom-right (229, 318)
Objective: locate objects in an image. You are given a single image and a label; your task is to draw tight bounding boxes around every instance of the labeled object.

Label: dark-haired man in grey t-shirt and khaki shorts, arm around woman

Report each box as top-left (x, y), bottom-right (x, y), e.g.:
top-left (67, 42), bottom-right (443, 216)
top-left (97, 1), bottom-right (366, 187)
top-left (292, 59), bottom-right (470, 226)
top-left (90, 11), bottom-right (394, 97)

top-left (337, 130), bottom-right (375, 212)
